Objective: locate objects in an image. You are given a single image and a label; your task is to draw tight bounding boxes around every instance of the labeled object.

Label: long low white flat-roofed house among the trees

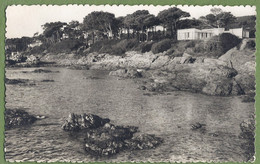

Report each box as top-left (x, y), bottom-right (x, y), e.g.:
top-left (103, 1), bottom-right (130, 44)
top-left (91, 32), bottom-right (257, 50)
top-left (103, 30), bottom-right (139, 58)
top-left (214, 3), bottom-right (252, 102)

top-left (177, 28), bottom-right (249, 40)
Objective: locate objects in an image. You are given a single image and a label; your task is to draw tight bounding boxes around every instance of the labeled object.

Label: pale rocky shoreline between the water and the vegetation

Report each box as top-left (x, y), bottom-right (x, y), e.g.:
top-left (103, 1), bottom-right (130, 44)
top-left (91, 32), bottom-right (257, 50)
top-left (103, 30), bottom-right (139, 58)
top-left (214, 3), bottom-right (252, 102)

top-left (7, 39), bottom-right (255, 99)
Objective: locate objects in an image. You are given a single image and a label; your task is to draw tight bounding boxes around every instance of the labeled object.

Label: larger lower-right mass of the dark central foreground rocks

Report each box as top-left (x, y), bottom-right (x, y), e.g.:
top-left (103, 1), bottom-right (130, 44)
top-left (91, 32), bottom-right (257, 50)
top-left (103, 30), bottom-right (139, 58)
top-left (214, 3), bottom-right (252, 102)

top-left (85, 125), bottom-right (162, 156)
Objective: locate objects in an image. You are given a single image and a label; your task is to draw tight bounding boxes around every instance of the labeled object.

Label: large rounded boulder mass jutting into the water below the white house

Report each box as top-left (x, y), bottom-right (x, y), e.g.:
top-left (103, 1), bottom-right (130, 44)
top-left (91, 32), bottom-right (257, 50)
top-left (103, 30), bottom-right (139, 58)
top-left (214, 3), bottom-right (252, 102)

top-left (143, 61), bottom-right (243, 96)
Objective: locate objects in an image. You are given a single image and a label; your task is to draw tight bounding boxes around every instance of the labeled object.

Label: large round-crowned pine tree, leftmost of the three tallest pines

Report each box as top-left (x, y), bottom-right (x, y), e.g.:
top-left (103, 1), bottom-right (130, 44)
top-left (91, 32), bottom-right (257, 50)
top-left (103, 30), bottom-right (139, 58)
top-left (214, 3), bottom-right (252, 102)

top-left (83, 11), bottom-right (118, 43)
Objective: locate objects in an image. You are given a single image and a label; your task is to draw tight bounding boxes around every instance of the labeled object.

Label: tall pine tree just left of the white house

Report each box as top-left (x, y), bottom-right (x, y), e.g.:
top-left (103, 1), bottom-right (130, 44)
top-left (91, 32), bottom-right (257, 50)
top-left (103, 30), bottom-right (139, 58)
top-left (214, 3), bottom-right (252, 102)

top-left (157, 7), bottom-right (190, 38)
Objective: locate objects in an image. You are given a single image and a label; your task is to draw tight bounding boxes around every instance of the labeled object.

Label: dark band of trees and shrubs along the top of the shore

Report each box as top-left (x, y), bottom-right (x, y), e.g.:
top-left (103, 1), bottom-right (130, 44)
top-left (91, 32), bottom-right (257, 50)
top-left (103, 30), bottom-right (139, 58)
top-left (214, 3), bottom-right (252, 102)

top-left (6, 7), bottom-right (255, 57)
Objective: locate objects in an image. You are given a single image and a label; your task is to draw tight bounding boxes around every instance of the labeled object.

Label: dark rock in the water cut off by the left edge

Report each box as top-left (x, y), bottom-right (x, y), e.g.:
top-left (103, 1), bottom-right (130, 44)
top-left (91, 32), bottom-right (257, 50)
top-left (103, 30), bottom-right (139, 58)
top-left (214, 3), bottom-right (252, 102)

top-left (5, 109), bottom-right (37, 129)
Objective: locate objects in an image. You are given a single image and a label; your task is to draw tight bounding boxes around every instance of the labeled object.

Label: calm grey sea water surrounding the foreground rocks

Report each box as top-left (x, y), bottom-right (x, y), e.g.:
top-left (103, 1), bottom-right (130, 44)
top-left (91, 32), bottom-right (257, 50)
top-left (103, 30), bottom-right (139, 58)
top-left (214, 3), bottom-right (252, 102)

top-left (5, 68), bottom-right (254, 162)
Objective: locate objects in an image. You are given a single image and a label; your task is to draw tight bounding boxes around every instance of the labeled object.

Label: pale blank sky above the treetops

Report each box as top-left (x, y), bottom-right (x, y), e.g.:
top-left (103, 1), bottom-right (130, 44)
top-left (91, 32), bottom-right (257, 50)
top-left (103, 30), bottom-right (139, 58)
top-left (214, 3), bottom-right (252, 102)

top-left (6, 5), bottom-right (256, 38)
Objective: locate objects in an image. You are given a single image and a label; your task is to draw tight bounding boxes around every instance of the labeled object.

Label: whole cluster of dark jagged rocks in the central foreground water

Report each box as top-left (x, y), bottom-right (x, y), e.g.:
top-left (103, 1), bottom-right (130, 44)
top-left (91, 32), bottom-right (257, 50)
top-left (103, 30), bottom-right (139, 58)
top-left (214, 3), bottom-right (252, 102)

top-left (62, 114), bottom-right (162, 156)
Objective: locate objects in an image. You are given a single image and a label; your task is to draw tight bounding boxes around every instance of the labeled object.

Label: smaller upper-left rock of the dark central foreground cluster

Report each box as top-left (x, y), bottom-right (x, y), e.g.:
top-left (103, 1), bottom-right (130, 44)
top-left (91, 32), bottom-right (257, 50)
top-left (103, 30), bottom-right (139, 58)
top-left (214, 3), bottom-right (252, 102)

top-left (62, 113), bottom-right (110, 131)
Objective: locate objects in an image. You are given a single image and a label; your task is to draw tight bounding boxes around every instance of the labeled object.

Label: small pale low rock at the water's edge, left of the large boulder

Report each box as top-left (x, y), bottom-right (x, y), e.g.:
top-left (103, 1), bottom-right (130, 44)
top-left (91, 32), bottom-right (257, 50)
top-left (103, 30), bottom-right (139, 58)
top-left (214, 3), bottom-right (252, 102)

top-left (109, 69), bottom-right (142, 78)
